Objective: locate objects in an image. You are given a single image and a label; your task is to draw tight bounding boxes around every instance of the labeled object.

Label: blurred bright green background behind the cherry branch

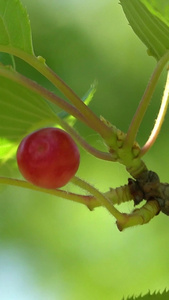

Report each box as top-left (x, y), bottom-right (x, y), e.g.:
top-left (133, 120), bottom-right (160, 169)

top-left (0, 0), bottom-right (169, 300)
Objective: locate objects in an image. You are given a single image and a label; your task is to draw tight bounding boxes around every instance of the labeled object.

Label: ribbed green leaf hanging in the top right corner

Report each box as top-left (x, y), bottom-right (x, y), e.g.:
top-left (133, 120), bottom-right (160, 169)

top-left (120, 0), bottom-right (169, 60)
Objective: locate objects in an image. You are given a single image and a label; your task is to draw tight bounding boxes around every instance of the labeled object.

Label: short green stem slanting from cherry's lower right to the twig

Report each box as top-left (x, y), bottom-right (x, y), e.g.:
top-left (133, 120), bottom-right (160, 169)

top-left (71, 176), bottom-right (125, 222)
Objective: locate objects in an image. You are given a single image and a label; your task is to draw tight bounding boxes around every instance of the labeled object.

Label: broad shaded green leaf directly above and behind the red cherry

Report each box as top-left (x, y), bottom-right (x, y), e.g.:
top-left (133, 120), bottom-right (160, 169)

top-left (0, 67), bottom-right (55, 162)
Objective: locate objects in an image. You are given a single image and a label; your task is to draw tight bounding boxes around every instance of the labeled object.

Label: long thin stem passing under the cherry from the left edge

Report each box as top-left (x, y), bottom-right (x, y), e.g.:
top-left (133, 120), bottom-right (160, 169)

top-left (0, 177), bottom-right (101, 210)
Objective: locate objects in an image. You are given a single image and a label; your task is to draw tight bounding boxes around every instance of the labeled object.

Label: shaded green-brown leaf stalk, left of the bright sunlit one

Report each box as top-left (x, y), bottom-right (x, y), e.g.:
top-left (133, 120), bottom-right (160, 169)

top-left (124, 51), bottom-right (169, 152)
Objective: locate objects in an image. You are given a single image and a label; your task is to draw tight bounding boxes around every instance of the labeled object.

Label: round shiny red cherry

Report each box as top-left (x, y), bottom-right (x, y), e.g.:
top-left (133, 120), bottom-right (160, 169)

top-left (16, 127), bottom-right (80, 189)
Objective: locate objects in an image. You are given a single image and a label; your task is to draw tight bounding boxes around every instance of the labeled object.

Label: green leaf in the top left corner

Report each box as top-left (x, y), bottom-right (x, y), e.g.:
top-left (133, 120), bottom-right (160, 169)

top-left (0, 0), bottom-right (33, 55)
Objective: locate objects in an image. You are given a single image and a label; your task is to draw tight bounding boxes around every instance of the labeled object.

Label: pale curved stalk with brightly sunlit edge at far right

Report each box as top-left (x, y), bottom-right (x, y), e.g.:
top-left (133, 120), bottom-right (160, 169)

top-left (139, 72), bottom-right (169, 156)
